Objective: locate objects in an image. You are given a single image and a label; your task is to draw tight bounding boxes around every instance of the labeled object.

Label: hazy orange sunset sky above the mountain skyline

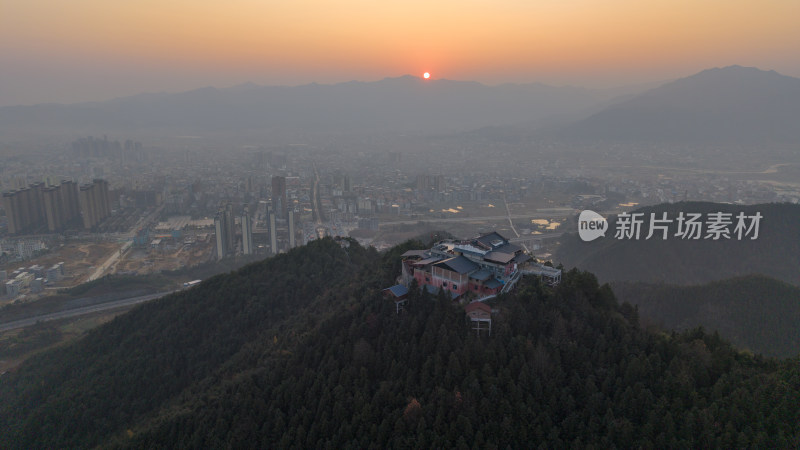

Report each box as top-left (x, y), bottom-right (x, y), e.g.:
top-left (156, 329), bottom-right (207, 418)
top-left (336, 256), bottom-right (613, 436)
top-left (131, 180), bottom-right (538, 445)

top-left (0, 0), bottom-right (800, 105)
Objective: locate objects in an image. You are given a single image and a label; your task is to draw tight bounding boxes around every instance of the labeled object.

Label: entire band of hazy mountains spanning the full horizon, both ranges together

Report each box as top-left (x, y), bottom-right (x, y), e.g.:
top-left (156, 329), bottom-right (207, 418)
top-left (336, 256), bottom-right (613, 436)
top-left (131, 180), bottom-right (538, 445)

top-left (0, 66), bottom-right (800, 144)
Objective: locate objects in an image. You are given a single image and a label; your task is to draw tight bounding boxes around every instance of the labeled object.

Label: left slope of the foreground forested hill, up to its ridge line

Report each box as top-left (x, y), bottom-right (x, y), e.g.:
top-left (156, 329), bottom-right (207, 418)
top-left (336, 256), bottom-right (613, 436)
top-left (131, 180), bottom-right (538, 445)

top-left (0, 240), bottom-right (388, 448)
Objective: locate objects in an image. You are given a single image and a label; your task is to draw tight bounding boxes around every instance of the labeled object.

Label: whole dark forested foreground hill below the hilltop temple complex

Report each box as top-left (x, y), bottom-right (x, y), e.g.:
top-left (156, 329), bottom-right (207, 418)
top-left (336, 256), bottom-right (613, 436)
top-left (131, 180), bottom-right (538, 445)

top-left (0, 239), bottom-right (800, 448)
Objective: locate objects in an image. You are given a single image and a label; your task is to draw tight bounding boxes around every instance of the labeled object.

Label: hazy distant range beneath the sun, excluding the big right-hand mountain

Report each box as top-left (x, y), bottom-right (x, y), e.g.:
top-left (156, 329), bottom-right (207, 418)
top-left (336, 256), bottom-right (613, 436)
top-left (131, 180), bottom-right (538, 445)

top-left (0, 75), bottom-right (616, 134)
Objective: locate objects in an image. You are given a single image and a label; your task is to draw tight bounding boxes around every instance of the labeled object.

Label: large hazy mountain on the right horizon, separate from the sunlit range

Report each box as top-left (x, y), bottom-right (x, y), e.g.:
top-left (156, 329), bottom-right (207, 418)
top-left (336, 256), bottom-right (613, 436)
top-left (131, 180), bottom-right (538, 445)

top-left (558, 66), bottom-right (800, 143)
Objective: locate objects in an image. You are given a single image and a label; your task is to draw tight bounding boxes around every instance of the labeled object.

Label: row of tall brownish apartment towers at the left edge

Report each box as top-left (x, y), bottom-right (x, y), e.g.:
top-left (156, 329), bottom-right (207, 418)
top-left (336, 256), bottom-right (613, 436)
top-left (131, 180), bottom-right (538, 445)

top-left (3, 179), bottom-right (111, 234)
